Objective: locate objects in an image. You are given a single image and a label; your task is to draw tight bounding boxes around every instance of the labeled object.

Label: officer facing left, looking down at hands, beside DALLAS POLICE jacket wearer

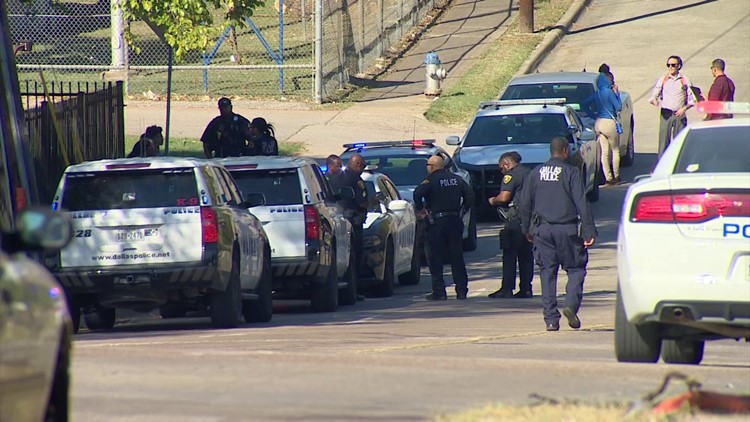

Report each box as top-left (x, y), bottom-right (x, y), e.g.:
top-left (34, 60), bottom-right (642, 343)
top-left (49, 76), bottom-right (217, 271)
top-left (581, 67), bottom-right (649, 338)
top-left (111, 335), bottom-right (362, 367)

top-left (488, 151), bottom-right (534, 298)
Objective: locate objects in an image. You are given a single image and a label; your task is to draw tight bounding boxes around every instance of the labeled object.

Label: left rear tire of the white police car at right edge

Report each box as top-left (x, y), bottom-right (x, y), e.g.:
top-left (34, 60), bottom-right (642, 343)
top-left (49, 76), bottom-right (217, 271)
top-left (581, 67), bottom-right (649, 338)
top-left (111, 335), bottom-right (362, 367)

top-left (615, 290), bottom-right (661, 363)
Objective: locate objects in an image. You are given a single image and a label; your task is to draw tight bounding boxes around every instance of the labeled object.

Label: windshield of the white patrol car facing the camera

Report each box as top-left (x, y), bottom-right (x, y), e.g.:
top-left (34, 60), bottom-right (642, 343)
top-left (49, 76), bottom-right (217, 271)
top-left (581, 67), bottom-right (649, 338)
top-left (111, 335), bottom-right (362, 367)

top-left (463, 113), bottom-right (570, 147)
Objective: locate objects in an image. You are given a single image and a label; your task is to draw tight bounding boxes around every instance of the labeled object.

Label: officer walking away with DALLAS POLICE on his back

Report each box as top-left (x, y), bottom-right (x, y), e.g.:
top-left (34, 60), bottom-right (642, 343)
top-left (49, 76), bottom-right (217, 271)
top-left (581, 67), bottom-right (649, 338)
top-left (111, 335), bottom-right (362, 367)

top-left (520, 137), bottom-right (596, 331)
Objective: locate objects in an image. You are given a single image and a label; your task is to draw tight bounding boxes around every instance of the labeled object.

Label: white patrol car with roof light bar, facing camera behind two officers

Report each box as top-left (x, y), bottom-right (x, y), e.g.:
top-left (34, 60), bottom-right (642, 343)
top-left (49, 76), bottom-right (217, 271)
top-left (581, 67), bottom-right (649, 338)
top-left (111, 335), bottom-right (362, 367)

top-left (446, 98), bottom-right (600, 211)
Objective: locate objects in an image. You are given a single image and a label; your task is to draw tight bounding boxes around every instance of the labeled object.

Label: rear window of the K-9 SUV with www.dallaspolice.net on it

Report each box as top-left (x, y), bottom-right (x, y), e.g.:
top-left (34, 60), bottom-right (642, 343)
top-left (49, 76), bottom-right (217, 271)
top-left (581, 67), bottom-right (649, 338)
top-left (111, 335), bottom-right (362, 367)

top-left (61, 168), bottom-right (200, 211)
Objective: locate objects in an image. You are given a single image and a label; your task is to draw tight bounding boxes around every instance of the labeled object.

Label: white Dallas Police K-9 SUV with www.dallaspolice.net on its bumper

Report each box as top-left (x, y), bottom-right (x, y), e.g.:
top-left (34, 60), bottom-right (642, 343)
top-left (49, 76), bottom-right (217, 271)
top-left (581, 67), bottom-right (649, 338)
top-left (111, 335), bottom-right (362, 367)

top-left (47, 157), bottom-right (272, 329)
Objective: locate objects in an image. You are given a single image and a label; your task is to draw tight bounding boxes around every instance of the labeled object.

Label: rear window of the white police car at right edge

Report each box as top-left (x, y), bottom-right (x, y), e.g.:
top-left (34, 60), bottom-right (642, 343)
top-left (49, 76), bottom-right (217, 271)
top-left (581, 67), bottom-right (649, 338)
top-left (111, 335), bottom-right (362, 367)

top-left (674, 126), bottom-right (750, 174)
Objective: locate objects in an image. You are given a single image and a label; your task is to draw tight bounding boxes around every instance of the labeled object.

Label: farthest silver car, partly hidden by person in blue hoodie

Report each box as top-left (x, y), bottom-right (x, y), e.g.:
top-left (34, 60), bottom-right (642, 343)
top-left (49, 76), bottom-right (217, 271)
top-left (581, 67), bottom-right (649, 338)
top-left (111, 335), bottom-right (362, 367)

top-left (499, 72), bottom-right (635, 167)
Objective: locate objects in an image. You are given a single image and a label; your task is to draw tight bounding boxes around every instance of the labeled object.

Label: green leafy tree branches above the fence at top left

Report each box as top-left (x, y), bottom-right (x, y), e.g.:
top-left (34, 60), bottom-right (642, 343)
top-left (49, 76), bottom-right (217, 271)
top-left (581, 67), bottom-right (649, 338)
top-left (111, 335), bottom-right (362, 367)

top-left (118, 0), bottom-right (264, 61)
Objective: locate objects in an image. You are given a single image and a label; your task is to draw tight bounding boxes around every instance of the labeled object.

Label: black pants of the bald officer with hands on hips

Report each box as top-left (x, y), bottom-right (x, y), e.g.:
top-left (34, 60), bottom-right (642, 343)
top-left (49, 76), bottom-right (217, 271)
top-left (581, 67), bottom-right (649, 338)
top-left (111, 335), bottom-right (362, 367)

top-left (427, 215), bottom-right (469, 296)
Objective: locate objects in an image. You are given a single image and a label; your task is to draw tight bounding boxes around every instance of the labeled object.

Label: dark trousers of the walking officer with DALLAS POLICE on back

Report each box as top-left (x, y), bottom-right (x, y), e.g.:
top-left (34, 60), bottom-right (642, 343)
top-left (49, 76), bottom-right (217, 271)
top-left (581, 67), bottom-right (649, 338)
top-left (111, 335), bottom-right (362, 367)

top-left (532, 224), bottom-right (589, 323)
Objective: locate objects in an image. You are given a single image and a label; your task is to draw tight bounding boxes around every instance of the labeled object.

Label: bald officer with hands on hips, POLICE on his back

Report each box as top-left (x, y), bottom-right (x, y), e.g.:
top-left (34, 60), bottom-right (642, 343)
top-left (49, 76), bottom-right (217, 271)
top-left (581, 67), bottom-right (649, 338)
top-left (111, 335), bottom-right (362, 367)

top-left (414, 155), bottom-right (474, 300)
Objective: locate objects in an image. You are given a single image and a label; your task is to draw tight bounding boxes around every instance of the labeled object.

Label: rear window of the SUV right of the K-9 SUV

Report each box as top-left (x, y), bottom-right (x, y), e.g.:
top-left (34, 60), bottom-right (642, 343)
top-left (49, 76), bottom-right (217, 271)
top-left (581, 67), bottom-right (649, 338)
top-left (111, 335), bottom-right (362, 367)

top-left (231, 168), bottom-right (302, 206)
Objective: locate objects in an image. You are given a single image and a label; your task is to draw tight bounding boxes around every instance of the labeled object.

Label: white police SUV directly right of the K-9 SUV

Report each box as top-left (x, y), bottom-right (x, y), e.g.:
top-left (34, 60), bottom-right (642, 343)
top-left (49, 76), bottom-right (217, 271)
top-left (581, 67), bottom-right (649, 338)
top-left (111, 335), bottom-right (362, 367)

top-left (218, 157), bottom-right (357, 312)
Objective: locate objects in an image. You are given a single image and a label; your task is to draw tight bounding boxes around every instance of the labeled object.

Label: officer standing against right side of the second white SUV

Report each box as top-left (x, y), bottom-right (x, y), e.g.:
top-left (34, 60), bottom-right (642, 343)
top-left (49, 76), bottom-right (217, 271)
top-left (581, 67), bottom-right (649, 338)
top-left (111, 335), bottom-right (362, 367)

top-left (329, 154), bottom-right (371, 276)
